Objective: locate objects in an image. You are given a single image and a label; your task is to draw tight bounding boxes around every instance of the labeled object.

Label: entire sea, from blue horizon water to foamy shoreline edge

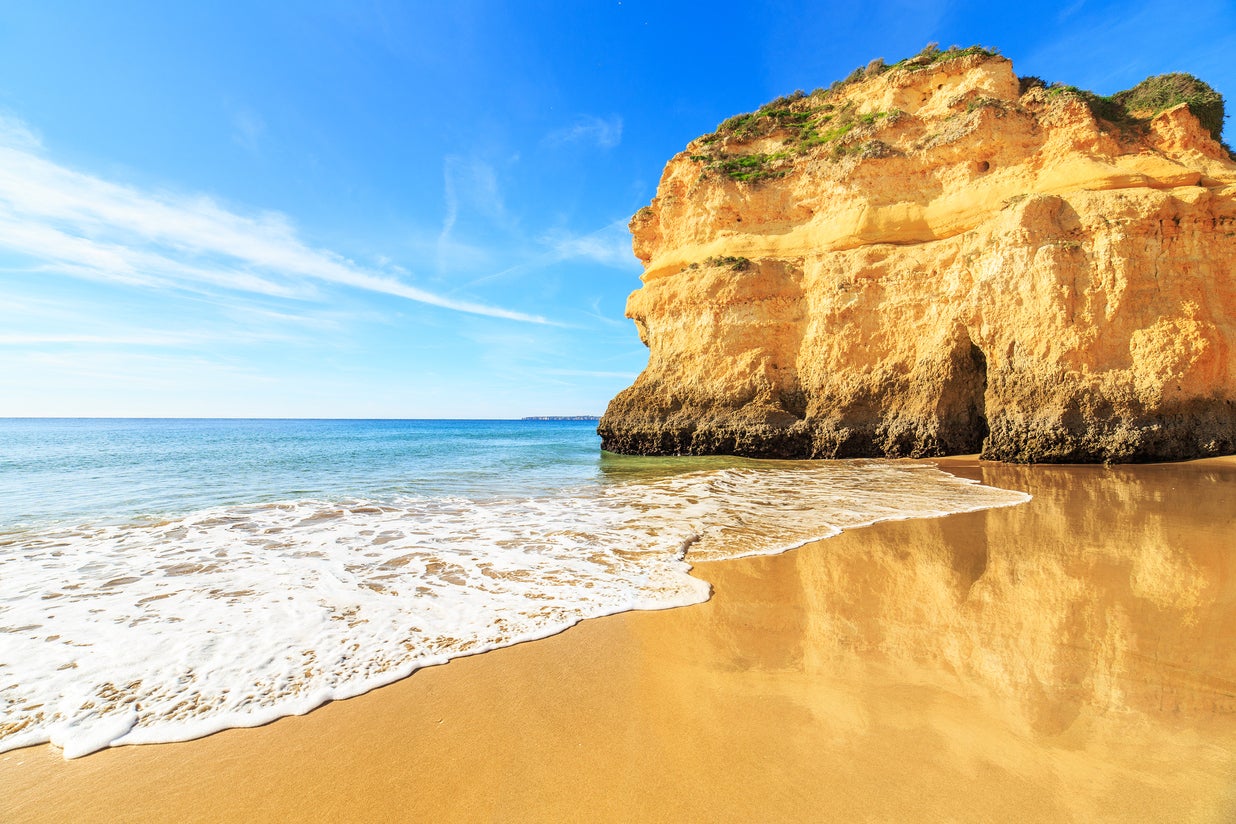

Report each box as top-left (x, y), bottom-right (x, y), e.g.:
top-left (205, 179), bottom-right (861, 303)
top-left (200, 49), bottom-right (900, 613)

top-left (0, 419), bottom-right (1027, 757)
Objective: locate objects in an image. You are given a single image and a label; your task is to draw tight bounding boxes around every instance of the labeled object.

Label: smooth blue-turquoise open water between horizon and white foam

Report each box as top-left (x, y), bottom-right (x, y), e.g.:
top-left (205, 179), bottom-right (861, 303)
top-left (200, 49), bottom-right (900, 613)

top-left (0, 419), bottom-right (602, 529)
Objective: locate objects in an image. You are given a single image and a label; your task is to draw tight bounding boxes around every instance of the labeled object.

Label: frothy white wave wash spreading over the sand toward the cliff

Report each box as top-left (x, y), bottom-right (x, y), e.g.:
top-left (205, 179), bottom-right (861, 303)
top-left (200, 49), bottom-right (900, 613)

top-left (0, 462), bottom-right (1027, 757)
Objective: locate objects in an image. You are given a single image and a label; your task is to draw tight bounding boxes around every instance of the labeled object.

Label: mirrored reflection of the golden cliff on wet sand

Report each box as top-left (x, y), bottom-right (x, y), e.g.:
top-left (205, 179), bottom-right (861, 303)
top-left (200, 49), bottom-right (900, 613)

top-left (680, 462), bottom-right (1236, 736)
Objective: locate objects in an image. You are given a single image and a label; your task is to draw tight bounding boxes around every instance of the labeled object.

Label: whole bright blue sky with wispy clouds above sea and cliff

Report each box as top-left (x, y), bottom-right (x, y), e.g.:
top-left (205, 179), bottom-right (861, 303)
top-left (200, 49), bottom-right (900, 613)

top-left (0, 0), bottom-right (1236, 418)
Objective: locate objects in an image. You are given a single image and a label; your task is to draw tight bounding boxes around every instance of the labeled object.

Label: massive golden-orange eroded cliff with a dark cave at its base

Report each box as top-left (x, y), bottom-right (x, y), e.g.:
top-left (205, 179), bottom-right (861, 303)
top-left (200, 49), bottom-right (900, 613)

top-left (598, 54), bottom-right (1236, 462)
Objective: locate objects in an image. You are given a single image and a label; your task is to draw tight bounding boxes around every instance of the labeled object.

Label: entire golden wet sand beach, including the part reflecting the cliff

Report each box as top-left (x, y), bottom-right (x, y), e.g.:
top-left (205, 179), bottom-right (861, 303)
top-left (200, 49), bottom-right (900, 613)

top-left (0, 458), bottom-right (1236, 823)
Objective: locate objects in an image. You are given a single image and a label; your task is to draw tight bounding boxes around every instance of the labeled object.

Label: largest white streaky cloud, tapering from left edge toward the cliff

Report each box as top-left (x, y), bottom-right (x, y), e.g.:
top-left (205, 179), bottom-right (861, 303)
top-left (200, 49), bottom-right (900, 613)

top-left (0, 121), bottom-right (549, 324)
